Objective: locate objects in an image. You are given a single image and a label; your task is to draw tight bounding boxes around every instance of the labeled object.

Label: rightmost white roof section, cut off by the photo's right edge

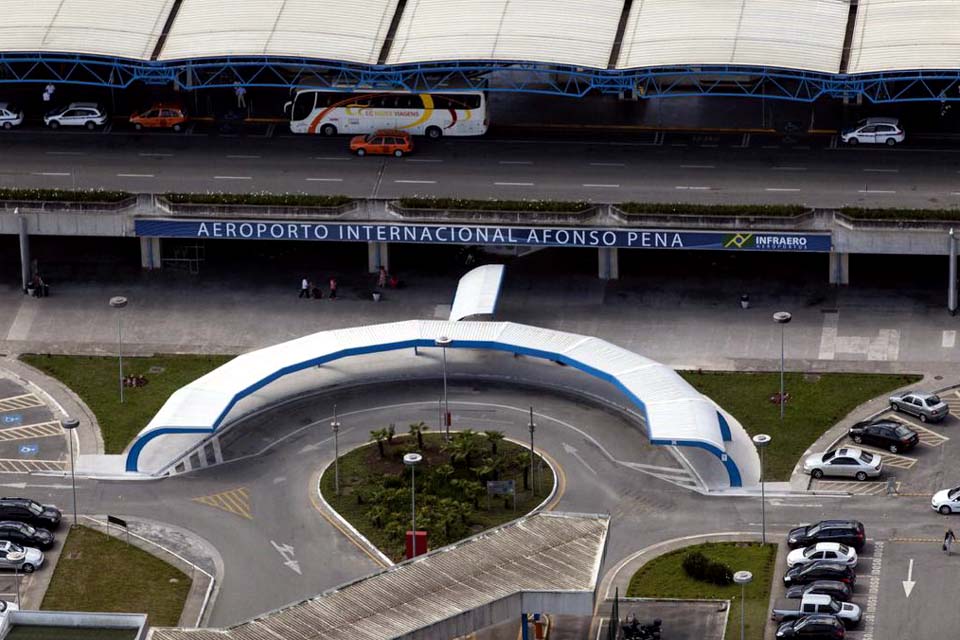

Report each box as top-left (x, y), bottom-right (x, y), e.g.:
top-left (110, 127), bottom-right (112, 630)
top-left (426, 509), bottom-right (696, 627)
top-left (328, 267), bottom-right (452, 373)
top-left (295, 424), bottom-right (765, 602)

top-left (847, 0), bottom-right (960, 73)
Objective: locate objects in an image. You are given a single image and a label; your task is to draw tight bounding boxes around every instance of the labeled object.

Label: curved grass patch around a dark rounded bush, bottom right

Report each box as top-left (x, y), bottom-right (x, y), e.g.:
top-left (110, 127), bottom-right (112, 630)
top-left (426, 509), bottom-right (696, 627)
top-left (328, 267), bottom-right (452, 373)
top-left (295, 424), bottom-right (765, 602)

top-left (627, 542), bottom-right (777, 640)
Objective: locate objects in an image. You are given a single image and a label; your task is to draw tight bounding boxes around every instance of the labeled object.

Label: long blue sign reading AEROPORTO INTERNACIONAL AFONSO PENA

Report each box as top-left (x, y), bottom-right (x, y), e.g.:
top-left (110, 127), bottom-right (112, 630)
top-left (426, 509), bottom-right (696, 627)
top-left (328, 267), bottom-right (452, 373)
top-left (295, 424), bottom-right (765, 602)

top-left (135, 219), bottom-right (832, 252)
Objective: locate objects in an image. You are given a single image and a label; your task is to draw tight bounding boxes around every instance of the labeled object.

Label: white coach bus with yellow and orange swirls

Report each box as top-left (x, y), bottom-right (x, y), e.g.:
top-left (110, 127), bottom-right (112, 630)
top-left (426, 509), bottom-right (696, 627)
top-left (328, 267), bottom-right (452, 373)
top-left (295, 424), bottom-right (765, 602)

top-left (286, 89), bottom-right (488, 138)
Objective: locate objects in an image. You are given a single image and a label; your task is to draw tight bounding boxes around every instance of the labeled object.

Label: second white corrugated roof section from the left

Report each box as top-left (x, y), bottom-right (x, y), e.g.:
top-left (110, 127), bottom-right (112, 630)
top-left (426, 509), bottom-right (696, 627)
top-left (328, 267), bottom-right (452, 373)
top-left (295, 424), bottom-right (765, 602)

top-left (160, 0), bottom-right (397, 64)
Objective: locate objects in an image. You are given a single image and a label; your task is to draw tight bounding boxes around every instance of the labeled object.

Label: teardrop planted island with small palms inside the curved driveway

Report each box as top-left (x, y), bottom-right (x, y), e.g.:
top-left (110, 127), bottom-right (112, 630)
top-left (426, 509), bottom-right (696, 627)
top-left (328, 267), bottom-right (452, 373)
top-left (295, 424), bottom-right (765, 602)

top-left (320, 433), bottom-right (553, 560)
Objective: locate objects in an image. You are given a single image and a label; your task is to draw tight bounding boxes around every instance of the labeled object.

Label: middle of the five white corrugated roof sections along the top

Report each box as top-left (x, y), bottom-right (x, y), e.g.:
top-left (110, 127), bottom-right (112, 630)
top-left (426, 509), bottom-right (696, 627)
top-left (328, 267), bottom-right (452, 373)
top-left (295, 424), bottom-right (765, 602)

top-left (387, 0), bottom-right (623, 69)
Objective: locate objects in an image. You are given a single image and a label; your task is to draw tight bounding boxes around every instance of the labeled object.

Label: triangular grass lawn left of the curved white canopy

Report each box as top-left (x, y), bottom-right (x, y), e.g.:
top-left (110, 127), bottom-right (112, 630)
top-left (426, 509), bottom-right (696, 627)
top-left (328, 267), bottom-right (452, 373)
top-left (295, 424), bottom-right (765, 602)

top-left (20, 354), bottom-right (230, 453)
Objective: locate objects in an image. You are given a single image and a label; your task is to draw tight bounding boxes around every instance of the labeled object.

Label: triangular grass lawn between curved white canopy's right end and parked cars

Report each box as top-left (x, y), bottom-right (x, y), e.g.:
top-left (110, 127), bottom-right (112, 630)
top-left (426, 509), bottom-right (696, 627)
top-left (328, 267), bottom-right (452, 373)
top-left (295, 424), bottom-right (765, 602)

top-left (679, 371), bottom-right (922, 481)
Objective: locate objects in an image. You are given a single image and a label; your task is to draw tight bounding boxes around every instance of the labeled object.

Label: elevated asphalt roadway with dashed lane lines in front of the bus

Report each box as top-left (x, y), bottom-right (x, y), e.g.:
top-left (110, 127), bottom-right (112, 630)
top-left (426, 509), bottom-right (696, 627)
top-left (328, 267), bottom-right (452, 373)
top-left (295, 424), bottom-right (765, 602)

top-left (0, 129), bottom-right (960, 207)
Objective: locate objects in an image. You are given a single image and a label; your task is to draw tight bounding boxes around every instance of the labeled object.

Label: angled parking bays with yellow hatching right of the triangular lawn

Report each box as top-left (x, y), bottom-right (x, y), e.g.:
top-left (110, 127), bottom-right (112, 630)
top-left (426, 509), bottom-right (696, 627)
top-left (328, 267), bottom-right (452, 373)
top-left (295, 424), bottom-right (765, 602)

top-left (810, 389), bottom-right (960, 497)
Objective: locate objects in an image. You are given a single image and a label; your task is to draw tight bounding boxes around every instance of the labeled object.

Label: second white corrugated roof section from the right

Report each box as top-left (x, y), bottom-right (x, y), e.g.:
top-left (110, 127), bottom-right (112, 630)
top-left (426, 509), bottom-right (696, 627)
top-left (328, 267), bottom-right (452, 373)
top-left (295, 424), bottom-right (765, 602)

top-left (617, 0), bottom-right (850, 73)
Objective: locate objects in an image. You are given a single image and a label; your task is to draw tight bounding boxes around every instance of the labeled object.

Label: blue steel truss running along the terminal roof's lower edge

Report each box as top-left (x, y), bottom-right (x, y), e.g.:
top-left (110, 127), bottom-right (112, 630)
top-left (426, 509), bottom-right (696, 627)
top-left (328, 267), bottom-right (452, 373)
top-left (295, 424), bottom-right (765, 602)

top-left (0, 53), bottom-right (960, 102)
